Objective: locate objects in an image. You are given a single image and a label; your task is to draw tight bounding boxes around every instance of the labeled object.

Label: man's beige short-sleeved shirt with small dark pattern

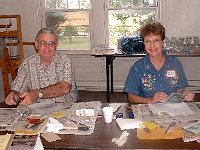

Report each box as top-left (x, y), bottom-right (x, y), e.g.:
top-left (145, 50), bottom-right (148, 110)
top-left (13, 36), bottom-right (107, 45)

top-left (11, 52), bottom-right (77, 102)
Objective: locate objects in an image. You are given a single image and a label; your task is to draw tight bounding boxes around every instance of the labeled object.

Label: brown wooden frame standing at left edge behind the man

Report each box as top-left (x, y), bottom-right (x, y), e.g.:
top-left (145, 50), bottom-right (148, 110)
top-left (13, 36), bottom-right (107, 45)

top-left (0, 15), bottom-right (24, 97)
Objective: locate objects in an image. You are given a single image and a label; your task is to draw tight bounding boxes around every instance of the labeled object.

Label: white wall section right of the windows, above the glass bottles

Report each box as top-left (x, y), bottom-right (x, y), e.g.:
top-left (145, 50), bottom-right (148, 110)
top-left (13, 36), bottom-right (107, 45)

top-left (165, 0), bottom-right (200, 36)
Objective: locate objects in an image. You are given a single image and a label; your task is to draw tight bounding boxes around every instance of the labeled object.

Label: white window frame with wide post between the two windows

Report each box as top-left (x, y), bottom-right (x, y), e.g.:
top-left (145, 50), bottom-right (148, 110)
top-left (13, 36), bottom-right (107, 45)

top-left (43, 0), bottom-right (159, 54)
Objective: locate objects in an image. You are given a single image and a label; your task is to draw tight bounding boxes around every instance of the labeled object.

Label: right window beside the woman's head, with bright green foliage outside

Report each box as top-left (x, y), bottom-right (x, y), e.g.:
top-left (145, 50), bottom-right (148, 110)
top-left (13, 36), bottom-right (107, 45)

top-left (108, 0), bottom-right (157, 47)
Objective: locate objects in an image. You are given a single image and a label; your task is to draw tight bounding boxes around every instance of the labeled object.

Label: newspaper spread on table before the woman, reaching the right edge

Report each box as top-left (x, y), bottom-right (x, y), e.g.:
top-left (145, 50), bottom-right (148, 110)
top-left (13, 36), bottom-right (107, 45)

top-left (132, 102), bottom-right (200, 143)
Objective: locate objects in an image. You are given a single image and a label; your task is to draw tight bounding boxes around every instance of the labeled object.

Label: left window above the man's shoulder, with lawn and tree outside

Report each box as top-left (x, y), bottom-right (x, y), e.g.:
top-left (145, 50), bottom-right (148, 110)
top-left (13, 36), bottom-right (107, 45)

top-left (45, 0), bottom-right (91, 50)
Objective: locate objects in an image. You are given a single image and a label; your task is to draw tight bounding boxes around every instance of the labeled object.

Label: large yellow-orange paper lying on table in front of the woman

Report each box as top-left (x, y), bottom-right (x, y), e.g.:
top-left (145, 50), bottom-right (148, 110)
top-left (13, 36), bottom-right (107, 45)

top-left (137, 127), bottom-right (184, 139)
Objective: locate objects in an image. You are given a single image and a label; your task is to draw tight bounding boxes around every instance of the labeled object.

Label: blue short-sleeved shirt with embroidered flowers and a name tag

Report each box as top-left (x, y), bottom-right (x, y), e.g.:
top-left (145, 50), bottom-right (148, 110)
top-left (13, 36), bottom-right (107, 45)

top-left (124, 55), bottom-right (188, 97)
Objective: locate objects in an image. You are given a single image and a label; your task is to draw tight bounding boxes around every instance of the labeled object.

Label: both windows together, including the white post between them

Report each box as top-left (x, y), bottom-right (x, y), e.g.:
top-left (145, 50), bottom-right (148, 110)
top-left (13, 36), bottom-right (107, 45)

top-left (45, 0), bottom-right (158, 50)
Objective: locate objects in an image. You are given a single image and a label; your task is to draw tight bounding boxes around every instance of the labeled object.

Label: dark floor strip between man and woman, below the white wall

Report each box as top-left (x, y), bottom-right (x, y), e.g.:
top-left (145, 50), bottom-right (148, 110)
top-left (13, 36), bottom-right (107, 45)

top-left (78, 90), bottom-right (127, 103)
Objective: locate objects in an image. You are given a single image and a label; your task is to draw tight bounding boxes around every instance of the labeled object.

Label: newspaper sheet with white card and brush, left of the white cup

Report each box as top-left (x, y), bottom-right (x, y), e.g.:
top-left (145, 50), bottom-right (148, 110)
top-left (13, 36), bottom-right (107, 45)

top-left (43, 101), bottom-right (101, 135)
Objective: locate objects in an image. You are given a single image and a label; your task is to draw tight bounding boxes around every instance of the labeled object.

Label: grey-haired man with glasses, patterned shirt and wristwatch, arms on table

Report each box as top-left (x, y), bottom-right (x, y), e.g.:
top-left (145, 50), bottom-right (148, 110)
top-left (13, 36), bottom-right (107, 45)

top-left (5, 28), bottom-right (77, 105)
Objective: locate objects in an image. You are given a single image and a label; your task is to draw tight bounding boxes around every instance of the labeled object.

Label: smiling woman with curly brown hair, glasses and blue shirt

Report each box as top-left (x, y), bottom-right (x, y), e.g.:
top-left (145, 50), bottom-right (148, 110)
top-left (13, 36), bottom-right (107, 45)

top-left (124, 22), bottom-right (194, 103)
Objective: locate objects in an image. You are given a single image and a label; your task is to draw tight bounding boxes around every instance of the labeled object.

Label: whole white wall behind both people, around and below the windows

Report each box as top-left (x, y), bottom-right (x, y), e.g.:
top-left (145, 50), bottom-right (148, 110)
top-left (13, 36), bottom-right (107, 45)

top-left (0, 0), bottom-right (200, 100)
